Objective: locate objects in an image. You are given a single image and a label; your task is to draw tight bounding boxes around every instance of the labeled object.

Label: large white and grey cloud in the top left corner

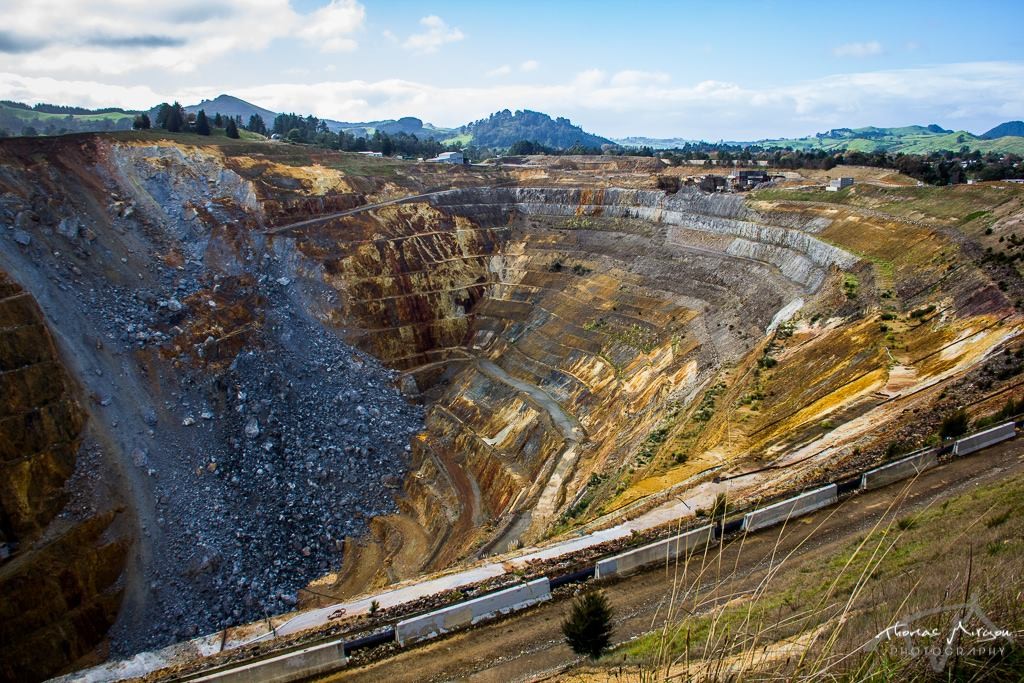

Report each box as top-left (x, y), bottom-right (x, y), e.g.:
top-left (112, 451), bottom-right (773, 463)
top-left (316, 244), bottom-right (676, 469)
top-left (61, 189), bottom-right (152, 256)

top-left (0, 0), bottom-right (366, 77)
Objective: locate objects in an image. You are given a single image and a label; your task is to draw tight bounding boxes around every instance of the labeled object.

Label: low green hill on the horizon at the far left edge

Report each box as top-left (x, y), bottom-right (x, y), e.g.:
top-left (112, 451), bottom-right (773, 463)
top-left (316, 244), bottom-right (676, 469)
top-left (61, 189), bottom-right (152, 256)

top-left (0, 100), bottom-right (138, 135)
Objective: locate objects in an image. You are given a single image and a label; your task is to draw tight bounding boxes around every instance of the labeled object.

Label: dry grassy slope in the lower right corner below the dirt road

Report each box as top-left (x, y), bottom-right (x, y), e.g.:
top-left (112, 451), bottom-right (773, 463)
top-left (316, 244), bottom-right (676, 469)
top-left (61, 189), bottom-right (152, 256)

top-left (566, 477), bottom-right (1024, 683)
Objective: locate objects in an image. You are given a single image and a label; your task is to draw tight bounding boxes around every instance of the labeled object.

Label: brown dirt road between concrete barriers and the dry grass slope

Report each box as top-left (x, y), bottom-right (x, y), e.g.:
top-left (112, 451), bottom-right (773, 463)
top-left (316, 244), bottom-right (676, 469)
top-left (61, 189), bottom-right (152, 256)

top-left (322, 439), bottom-right (1024, 683)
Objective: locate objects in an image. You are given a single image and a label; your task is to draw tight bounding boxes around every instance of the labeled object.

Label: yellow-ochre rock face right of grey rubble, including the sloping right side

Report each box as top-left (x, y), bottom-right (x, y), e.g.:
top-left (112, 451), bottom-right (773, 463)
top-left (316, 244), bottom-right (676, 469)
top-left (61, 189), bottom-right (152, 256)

top-left (302, 183), bottom-right (1019, 593)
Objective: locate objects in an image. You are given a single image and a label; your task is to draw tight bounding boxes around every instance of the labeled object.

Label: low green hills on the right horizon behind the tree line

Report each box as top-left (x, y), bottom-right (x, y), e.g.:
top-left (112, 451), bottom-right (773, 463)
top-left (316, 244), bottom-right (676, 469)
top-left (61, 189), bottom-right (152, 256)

top-left (754, 124), bottom-right (1024, 155)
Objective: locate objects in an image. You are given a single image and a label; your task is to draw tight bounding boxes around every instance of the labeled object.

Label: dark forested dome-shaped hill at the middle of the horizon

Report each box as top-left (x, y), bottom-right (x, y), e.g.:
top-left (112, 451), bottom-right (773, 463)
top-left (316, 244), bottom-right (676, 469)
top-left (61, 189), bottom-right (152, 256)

top-left (459, 110), bottom-right (613, 150)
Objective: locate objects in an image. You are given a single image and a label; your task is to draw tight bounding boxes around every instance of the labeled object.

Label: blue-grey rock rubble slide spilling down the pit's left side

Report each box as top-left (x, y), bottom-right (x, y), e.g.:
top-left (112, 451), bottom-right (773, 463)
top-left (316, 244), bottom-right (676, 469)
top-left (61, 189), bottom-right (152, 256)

top-left (0, 160), bottom-right (423, 657)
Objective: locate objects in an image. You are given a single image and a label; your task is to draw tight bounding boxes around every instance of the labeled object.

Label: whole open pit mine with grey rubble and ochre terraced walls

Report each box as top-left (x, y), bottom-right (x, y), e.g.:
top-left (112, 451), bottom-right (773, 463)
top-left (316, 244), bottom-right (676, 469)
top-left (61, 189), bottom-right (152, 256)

top-left (0, 132), bottom-right (1024, 680)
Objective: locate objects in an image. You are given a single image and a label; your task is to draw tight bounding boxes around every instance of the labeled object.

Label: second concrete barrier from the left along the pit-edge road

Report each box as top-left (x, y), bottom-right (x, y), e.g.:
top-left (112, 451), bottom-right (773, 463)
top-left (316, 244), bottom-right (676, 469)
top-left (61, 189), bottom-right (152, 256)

top-left (394, 578), bottom-right (551, 645)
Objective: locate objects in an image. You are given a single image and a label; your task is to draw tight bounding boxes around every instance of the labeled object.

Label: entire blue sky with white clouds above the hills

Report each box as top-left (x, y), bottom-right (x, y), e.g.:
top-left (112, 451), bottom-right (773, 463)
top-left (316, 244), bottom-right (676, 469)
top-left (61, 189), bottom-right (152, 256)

top-left (0, 0), bottom-right (1024, 140)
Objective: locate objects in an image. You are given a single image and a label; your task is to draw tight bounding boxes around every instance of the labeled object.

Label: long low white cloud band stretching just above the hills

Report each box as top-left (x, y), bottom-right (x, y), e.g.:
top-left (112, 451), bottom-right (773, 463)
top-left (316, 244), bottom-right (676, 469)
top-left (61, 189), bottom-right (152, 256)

top-left (0, 61), bottom-right (1024, 140)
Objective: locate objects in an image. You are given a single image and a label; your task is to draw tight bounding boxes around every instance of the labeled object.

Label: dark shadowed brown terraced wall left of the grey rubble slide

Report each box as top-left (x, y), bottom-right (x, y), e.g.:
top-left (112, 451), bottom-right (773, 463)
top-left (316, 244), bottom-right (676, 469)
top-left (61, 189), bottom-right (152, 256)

top-left (0, 271), bottom-right (127, 681)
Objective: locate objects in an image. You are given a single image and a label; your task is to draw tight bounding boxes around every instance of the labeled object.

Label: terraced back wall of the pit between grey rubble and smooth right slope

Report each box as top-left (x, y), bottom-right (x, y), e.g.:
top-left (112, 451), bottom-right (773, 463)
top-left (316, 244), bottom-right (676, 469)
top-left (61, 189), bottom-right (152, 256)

top-left (289, 187), bottom-right (857, 593)
